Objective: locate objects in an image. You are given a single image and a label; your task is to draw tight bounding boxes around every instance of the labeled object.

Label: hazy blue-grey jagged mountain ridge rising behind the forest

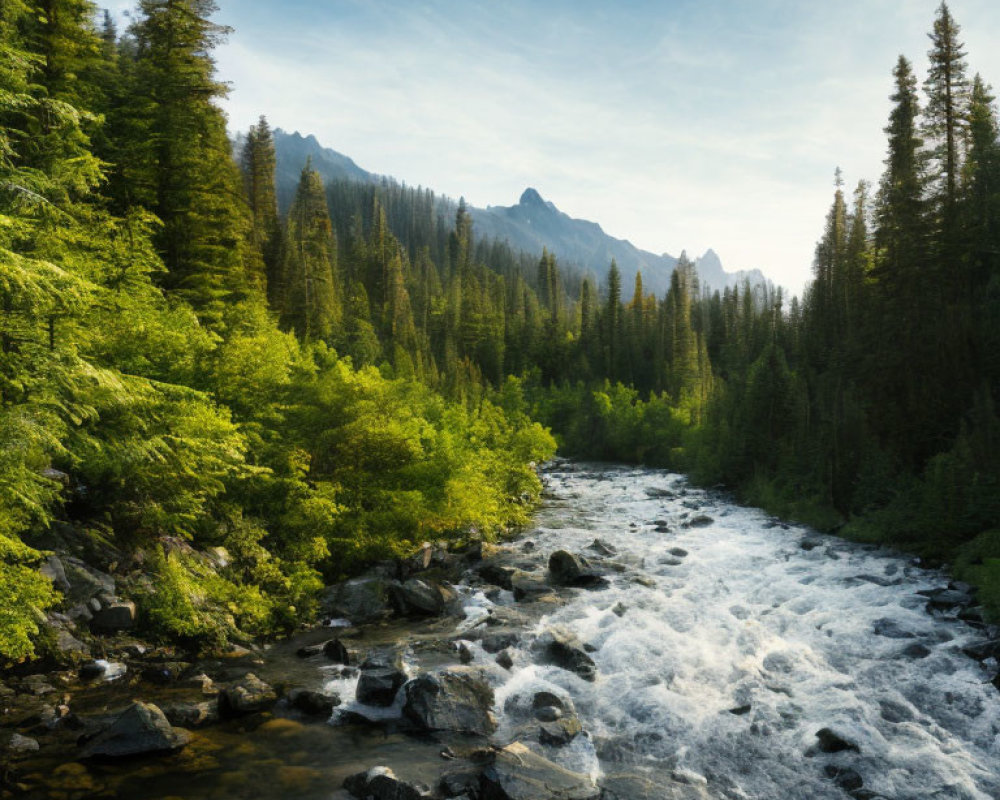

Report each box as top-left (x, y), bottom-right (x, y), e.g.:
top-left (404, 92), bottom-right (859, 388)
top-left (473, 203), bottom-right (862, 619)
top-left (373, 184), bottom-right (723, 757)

top-left (266, 128), bottom-right (765, 298)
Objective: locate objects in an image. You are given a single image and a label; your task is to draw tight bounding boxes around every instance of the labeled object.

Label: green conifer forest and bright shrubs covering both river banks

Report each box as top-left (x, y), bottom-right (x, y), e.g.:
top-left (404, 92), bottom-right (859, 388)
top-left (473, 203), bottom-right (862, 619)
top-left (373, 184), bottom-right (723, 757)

top-left (0, 0), bottom-right (1000, 660)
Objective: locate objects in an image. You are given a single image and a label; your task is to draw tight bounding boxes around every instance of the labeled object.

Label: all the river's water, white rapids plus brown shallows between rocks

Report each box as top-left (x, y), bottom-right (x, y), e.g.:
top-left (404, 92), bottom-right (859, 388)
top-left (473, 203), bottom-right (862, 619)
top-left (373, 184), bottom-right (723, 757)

top-left (17, 463), bottom-right (1000, 800)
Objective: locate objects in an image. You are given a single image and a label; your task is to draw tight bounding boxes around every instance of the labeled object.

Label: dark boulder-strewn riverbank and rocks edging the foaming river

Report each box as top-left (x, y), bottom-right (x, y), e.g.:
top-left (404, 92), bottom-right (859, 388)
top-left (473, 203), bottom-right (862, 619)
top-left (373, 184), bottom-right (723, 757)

top-left (0, 463), bottom-right (1000, 800)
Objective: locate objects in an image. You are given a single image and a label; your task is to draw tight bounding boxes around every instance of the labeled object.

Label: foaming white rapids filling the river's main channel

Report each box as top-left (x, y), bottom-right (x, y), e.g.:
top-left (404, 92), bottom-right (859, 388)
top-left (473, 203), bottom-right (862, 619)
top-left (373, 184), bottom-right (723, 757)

top-left (473, 464), bottom-right (1000, 800)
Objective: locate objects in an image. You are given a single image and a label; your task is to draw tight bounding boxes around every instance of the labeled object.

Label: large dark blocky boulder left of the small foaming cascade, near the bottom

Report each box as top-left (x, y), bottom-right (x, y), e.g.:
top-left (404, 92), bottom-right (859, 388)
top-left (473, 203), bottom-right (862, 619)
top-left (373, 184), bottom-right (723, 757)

top-left (403, 667), bottom-right (497, 735)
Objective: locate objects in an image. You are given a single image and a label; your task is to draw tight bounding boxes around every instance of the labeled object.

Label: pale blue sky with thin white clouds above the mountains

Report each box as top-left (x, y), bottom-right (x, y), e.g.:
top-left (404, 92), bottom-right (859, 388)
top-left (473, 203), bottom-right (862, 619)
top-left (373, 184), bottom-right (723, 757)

top-left (109, 0), bottom-right (1000, 293)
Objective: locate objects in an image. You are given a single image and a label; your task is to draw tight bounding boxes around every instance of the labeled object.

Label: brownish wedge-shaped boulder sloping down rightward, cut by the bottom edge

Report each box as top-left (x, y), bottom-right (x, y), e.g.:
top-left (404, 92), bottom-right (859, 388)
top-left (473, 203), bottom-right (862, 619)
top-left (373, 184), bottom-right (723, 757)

top-left (480, 742), bottom-right (601, 800)
